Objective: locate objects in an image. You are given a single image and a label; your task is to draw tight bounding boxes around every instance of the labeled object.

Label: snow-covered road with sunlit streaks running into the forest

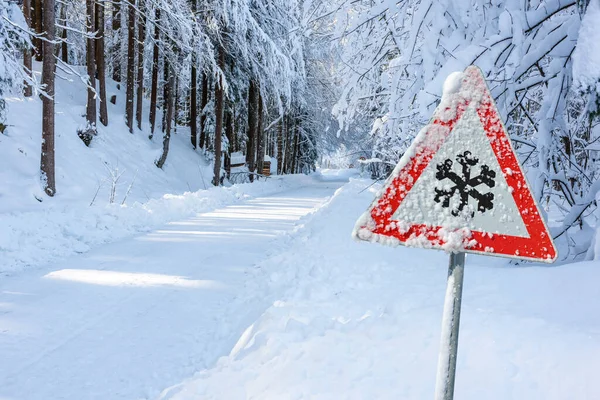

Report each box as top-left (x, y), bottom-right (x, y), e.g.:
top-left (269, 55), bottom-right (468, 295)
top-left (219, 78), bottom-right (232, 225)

top-left (0, 181), bottom-right (342, 400)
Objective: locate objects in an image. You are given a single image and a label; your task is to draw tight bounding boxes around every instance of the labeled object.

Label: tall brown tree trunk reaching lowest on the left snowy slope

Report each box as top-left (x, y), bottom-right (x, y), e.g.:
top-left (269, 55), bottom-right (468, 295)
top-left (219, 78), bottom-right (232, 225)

top-left (39, 0), bottom-right (56, 196)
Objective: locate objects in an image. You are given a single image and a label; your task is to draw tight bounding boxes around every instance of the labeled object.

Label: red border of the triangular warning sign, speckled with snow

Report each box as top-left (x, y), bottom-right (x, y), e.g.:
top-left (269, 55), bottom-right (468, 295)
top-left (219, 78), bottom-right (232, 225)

top-left (360, 66), bottom-right (557, 262)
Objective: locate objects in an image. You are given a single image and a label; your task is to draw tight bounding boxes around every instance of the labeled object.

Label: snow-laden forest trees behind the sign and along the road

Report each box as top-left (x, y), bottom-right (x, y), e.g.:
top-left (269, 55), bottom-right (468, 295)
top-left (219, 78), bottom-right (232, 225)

top-left (0, 0), bottom-right (600, 256)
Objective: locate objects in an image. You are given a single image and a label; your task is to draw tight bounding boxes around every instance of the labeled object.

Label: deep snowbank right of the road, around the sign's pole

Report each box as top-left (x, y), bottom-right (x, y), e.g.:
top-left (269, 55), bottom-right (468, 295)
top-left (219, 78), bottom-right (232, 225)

top-left (166, 180), bottom-right (600, 400)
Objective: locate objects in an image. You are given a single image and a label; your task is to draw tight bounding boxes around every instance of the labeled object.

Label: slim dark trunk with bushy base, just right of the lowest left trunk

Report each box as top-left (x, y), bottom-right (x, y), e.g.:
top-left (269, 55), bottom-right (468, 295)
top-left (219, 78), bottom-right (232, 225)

top-left (79, 0), bottom-right (97, 146)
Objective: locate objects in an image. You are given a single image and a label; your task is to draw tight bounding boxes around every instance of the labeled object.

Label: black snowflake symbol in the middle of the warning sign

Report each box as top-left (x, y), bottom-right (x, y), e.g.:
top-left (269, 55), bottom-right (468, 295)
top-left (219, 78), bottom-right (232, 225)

top-left (434, 151), bottom-right (496, 217)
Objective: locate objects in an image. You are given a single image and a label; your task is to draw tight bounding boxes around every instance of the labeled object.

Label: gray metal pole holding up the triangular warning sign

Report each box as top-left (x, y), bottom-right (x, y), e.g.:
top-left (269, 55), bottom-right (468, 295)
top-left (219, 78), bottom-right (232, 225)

top-left (435, 253), bottom-right (465, 400)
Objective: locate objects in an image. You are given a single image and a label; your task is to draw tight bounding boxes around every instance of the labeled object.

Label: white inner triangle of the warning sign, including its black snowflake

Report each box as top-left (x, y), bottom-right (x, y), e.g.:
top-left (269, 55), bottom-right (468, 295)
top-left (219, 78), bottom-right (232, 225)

top-left (392, 106), bottom-right (529, 237)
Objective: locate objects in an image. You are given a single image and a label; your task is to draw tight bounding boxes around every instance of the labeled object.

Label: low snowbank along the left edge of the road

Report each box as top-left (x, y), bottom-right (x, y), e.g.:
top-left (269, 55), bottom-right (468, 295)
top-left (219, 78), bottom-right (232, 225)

top-left (0, 175), bottom-right (310, 274)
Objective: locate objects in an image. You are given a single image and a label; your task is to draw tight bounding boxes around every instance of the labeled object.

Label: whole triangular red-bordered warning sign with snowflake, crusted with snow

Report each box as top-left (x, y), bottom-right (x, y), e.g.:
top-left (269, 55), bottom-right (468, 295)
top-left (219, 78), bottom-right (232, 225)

top-left (354, 66), bottom-right (557, 262)
